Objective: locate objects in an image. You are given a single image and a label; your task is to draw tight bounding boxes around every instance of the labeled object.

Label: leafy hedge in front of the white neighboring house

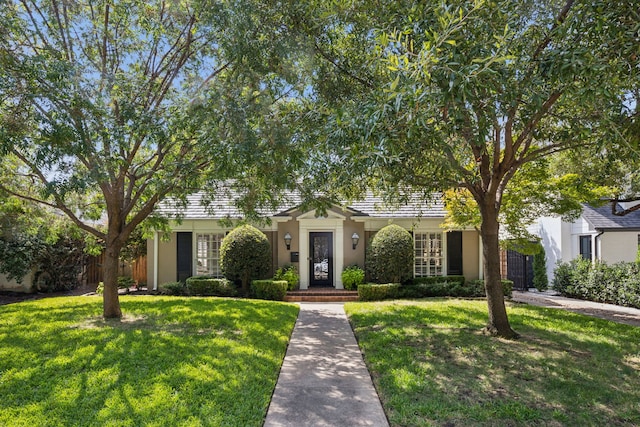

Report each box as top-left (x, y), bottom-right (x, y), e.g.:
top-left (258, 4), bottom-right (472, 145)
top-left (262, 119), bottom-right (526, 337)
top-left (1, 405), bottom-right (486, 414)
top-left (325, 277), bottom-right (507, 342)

top-left (553, 259), bottom-right (640, 308)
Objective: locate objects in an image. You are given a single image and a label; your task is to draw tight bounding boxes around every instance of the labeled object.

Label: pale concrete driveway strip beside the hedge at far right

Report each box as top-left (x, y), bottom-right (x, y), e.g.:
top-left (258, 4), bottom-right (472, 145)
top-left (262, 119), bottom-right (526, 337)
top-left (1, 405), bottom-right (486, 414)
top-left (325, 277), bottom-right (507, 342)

top-left (512, 289), bottom-right (640, 326)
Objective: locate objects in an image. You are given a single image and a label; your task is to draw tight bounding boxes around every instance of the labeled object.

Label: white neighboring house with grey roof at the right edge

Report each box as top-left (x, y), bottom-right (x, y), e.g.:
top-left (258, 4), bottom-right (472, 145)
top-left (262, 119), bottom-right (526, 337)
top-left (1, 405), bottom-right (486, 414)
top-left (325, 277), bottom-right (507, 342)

top-left (531, 205), bottom-right (640, 281)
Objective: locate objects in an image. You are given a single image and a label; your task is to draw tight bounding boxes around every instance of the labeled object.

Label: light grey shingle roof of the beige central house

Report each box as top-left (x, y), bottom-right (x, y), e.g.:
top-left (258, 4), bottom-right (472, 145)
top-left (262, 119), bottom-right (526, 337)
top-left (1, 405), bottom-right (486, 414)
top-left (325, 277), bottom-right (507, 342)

top-left (156, 191), bottom-right (445, 219)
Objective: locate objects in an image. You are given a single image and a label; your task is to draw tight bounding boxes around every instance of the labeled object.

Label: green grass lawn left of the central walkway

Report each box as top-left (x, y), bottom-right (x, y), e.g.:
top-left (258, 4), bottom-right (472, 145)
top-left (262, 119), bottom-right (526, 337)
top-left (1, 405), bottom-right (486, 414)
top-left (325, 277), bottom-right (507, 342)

top-left (0, 296), bottom-right (298, 426)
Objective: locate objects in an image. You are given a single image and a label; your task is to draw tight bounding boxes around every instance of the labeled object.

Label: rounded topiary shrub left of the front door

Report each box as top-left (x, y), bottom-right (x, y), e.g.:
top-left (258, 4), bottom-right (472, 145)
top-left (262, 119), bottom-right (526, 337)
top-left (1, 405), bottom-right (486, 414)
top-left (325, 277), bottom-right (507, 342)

top-left (220, 225), bottom-right (271, 295)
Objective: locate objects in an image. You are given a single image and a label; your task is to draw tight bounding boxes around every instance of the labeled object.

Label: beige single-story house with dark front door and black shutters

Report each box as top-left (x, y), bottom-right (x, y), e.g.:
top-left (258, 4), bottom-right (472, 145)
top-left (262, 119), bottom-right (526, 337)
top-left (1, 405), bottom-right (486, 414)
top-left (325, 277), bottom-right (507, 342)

top-left (147, 194), bottom-right (482, 289)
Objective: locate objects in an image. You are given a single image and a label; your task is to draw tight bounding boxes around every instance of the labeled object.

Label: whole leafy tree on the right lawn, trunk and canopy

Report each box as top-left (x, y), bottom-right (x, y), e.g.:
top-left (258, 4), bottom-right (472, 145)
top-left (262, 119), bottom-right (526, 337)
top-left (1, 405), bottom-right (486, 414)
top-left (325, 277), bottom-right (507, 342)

top-left (292, 0), bottom-right (640, 337)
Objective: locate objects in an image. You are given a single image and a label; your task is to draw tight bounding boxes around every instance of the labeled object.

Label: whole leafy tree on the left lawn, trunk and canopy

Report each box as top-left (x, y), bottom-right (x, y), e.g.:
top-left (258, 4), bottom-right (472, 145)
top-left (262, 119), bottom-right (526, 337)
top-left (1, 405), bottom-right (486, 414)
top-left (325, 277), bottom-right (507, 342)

top-left (0, 0), bottom-right (304, 317)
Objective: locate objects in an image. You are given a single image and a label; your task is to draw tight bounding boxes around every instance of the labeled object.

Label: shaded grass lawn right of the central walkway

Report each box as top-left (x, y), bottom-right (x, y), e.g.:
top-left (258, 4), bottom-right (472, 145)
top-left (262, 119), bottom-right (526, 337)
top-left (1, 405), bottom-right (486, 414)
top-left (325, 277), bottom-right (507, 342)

top-left (345, 299), bottom-right (640, 426)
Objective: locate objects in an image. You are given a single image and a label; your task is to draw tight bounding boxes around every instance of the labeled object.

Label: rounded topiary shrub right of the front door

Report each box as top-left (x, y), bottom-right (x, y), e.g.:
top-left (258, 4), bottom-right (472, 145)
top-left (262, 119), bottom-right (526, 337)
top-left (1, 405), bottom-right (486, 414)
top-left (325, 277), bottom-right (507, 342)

top-left (366, 224), bottom-right (413, 283)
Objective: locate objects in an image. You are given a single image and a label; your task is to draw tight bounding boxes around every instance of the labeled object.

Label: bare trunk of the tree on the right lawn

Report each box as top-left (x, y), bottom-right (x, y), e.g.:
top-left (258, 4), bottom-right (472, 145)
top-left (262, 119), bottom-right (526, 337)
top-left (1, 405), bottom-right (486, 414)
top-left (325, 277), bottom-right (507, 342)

top-left (480, 205), bottom-right (518, 339)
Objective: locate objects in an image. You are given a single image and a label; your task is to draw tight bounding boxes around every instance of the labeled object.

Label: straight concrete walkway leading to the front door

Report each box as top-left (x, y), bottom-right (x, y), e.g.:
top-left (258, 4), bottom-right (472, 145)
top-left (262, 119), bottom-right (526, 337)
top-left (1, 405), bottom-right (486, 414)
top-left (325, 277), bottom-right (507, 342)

top-left (264, 303), bottom-right (389, 427)
